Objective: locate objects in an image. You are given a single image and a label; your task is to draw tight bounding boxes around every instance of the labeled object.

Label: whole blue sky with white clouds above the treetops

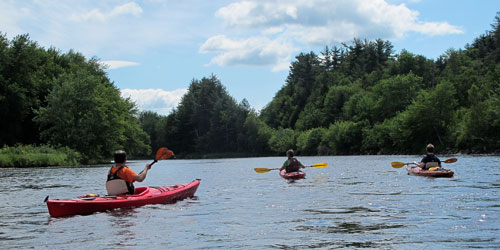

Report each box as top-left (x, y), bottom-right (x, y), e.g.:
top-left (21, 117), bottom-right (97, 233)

top-left (0, 0), bottom-right (500, 115)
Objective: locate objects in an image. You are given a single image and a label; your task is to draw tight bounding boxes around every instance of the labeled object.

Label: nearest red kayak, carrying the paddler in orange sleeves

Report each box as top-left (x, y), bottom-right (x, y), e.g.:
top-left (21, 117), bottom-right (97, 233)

top-left (45, 179), bottom-right (200, 217)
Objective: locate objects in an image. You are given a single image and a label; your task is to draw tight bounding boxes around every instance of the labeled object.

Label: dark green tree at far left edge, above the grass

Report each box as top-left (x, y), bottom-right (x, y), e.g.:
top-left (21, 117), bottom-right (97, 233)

top-left (0, 32), bottom-right (63, 145)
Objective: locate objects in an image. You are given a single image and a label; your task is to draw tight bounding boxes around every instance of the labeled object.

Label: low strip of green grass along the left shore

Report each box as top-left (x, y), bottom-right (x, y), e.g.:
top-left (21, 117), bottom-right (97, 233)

top-left (0, 145), bottom-right (81, 168)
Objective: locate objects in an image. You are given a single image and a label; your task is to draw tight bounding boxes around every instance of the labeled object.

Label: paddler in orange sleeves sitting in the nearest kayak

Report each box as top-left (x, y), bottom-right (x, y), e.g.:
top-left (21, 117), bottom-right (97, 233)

top-left (106, 150), bottom-right (151, 195)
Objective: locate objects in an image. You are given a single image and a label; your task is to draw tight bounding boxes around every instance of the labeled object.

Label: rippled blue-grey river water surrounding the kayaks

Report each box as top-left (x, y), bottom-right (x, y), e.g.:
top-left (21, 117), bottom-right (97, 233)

top-left (0, 156), bottom-right (500, 249)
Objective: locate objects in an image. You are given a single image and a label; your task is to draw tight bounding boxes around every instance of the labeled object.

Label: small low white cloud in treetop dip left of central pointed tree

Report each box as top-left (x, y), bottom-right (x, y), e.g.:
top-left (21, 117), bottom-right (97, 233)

top-left (121, 89), bottom-right (188, 115)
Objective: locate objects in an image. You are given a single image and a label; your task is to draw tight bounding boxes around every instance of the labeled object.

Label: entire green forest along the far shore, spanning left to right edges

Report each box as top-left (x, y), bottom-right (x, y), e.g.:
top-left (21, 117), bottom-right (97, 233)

top-left (0, 14), bottom-right (500, 162)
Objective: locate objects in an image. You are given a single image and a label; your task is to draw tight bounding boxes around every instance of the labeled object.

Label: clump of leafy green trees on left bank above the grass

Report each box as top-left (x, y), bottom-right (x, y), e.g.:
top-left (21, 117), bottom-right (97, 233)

top-left (0, 33), bottom-right (151, 163)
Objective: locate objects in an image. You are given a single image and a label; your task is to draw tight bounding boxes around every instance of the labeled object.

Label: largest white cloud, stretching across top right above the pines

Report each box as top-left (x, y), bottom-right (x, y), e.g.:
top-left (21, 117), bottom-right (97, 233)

top-left (216, 0), bottom-right (463, 39)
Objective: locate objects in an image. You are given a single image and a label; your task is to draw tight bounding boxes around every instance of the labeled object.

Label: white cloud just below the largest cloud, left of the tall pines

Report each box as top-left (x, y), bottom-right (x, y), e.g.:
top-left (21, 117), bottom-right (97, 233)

top-left (200, 35), bottom-right (295, 71)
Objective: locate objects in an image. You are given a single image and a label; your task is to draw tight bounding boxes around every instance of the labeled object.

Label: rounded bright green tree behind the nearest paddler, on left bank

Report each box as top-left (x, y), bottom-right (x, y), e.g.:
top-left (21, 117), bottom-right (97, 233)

top-left (35, 54), bottom-right (150, 161)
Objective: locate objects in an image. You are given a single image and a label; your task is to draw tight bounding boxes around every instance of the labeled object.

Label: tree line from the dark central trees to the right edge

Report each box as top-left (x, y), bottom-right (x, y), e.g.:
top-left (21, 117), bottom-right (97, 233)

top-left (140, 15), bottom-right (500, 155)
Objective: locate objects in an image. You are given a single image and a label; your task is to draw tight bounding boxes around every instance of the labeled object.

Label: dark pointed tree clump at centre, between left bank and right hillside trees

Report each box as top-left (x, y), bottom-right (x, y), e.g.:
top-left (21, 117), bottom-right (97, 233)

top-left (157, 76), bottom-right (250, 156)
